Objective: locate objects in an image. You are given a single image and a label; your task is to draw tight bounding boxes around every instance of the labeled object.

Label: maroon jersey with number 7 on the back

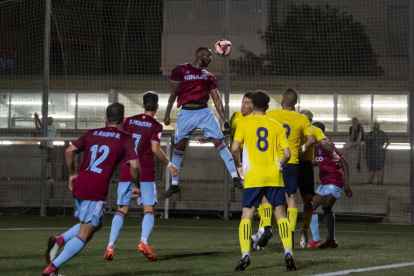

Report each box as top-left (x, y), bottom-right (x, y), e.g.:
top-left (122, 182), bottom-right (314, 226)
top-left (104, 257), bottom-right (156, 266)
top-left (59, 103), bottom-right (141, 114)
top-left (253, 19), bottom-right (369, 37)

top-left (119, 114), bottom-right (162, 182)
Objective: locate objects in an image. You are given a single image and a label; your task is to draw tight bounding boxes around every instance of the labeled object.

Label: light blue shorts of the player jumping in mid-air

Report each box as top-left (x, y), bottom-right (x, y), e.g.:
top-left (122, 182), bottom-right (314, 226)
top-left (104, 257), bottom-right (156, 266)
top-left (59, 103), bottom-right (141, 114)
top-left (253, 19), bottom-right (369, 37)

top-left (174, 107), bottom-right (224, 144)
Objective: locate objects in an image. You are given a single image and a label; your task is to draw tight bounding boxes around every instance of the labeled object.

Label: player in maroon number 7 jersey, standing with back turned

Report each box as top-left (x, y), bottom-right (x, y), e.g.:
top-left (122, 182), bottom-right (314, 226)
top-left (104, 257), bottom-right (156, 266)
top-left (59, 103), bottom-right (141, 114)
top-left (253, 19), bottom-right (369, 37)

top-left (104, 91), bottom-right (178, 261)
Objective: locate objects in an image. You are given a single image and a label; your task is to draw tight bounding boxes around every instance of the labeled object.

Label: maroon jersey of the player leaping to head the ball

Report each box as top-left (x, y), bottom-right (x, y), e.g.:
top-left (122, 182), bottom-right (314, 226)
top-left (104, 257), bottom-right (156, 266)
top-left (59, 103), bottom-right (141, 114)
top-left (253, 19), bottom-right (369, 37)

top-left (171, 63), bottom-right (217, 107)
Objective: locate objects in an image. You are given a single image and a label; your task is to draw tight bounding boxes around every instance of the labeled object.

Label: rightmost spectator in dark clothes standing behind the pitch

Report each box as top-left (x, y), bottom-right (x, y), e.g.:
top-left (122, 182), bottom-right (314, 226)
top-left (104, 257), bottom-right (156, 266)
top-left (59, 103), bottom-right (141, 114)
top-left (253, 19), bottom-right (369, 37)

top-left (365, 121), bottom-right (390, 186)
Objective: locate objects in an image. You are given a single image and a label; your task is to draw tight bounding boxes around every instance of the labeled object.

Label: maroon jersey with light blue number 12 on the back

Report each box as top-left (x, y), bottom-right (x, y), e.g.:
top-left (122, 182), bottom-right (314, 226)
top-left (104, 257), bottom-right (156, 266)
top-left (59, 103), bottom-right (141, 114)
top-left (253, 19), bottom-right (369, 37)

top-left (72, 126), bottom-right (138, 201)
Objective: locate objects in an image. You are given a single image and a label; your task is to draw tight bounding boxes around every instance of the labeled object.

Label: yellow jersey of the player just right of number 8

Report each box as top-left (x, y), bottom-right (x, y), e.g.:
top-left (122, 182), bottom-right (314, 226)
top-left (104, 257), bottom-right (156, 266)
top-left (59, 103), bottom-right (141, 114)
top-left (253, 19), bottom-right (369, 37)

top-left (266, 109), bottom-right (313, 164)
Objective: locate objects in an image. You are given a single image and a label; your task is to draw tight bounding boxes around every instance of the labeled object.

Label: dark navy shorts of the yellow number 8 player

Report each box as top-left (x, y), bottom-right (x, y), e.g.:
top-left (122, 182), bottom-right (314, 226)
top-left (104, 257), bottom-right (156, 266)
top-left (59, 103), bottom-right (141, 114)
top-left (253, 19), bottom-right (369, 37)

top-left (242, 187), bottom-right (286, 208)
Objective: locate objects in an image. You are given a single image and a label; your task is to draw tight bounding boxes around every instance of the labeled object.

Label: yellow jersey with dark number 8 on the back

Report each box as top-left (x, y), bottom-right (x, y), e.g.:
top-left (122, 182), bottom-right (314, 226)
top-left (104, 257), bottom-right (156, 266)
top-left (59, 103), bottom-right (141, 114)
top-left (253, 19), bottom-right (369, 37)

top-left (234, 115), bottom-right (288, 188)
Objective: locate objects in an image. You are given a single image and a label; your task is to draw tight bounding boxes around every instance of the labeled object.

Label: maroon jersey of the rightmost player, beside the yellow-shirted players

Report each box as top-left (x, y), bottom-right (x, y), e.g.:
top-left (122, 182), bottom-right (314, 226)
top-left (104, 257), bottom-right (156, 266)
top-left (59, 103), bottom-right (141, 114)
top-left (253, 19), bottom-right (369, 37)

top-left (314, 142), bottom-right (345, 188)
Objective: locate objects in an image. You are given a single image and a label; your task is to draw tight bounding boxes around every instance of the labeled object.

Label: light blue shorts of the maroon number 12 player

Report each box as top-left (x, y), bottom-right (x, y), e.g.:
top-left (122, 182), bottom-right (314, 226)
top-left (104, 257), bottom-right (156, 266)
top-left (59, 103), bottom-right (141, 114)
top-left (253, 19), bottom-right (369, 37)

top-left (75, 197), bottom-right (106, 227)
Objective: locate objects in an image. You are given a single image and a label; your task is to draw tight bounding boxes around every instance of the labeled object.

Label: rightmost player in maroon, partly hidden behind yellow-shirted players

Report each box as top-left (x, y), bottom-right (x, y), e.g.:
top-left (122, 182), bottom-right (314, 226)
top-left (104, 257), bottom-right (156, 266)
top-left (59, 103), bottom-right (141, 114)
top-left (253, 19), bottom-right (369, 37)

top-left (308, 122), bottom-right (352, 249)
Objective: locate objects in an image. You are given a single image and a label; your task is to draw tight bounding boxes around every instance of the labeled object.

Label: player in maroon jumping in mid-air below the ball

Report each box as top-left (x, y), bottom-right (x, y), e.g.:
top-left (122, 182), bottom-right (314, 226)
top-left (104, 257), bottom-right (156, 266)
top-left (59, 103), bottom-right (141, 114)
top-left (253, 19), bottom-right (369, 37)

top-left (164, 47), bottom-right (243, 198)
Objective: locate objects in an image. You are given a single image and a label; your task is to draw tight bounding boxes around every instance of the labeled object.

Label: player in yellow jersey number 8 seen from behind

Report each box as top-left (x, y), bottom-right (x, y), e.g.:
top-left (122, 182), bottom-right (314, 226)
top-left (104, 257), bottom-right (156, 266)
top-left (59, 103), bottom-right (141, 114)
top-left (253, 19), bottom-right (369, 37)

top-left (231, 91), bottom-right (296, 271)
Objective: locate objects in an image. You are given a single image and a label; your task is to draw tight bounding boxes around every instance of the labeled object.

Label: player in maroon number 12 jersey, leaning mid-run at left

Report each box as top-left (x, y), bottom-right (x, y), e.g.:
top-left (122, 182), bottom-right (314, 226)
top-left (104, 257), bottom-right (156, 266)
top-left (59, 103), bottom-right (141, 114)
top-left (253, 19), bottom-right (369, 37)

top-left (43, 103), bottom-right (141, 276)
